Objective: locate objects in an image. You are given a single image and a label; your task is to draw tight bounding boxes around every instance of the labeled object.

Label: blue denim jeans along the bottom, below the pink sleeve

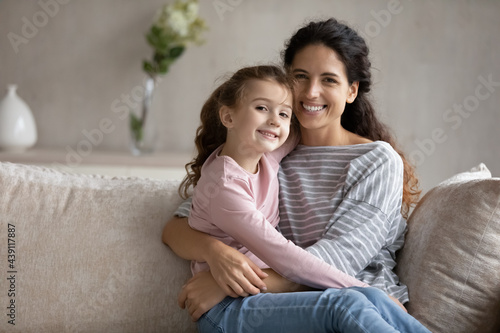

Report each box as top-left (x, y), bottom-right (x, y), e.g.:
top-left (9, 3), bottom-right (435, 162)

top-left (198, 287), bottom-right (430, 333)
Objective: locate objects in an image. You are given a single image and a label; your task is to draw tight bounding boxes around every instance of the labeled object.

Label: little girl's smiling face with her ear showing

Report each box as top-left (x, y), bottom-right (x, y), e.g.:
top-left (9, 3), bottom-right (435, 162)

top-left (221, 79), bottom-right (293, 155)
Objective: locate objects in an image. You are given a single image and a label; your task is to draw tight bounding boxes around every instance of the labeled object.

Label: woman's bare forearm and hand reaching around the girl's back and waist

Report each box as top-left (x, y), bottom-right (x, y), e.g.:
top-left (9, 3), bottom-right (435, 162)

top-left (162, 217), bottom-right (267, 297)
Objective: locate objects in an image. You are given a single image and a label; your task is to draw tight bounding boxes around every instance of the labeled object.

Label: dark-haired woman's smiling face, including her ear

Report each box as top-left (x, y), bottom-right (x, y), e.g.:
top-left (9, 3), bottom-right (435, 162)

top-left (291, 44), bottom-right (358, 131)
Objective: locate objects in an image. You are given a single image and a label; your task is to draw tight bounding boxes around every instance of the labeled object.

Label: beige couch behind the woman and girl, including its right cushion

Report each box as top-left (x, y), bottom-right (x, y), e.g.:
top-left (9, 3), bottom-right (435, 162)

top-left (0, 163), bottom-right (500, 333)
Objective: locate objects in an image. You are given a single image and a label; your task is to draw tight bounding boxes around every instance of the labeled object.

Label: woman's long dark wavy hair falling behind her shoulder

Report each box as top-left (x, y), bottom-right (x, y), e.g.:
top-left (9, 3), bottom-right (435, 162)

top-left (281, 18), bottom-right (421, 218)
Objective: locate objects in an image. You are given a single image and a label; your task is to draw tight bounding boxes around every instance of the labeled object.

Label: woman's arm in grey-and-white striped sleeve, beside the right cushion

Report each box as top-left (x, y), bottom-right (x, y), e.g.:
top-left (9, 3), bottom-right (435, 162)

top-left (307, 150), bottom-right (406, 276)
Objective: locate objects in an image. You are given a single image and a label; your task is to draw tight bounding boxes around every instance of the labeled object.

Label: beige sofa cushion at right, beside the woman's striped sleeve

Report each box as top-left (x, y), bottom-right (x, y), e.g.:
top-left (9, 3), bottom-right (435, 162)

top-left (397, 165), bottom-right (500, 333)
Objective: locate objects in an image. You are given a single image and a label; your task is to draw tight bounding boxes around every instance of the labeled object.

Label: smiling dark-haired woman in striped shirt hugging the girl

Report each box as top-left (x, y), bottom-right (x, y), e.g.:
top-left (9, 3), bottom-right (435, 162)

top-left (163, 19), bottom-right (418, 332)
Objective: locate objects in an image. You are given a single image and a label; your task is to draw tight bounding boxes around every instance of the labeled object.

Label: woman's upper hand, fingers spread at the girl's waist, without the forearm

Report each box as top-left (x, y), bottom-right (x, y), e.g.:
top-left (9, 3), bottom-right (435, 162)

top-left (207, 242), bottom-right (267, 297)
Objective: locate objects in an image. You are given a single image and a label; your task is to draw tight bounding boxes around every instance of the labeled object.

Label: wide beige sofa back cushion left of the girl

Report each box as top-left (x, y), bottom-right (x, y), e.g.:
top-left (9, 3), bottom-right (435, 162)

top-left (0, 163), bottom-right (196, 333)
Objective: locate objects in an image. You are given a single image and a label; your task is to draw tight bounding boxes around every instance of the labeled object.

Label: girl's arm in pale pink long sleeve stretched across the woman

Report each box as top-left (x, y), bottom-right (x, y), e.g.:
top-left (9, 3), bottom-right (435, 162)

top-left (208, 179), bottom-right (367, 289)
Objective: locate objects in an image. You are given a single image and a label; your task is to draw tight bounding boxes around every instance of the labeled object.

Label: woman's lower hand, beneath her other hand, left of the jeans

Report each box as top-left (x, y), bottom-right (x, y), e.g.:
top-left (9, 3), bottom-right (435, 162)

top-left (177, 272), bottom-right (226, 321)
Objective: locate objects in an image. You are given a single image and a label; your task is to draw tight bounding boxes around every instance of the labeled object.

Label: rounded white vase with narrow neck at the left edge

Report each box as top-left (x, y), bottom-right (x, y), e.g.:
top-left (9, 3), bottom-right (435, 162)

top-left (0, 85), bottom-right (37, 152)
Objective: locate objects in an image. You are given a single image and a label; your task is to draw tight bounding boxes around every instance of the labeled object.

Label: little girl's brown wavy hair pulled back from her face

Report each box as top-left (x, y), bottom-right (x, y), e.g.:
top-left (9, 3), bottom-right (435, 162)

top-left (179, 65), bottom-right (292, 199)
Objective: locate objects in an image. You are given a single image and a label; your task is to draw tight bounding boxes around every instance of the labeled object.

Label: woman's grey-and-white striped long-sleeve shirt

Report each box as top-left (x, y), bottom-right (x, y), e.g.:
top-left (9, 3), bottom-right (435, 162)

top-left (175, 141), bottom-right (408, 303)
